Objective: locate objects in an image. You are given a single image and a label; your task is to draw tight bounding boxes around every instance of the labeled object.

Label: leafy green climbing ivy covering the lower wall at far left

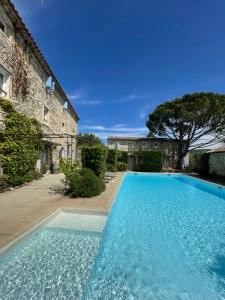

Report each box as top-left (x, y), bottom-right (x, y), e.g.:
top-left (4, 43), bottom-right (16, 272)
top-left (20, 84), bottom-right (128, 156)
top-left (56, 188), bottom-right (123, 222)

top-left (0, 98), bottom-right (42, 186)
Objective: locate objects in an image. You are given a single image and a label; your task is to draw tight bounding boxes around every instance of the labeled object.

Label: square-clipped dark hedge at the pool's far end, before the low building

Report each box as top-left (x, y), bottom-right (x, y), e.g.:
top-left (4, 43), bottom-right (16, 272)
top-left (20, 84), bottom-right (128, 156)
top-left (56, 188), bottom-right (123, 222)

top-left (134, 151), bottom-right (163, 172)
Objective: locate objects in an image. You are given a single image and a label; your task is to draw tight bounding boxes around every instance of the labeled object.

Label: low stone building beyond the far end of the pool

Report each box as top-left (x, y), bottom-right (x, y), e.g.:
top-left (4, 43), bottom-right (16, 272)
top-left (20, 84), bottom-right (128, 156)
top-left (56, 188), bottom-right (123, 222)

top-left (107, 136), bottom-right (181, 169)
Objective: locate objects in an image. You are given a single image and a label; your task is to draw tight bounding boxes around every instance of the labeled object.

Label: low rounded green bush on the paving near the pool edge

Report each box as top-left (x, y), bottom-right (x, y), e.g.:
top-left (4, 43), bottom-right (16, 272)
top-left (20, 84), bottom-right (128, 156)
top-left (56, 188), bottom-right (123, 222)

top-left (68, 168), bottom-right (105, 198)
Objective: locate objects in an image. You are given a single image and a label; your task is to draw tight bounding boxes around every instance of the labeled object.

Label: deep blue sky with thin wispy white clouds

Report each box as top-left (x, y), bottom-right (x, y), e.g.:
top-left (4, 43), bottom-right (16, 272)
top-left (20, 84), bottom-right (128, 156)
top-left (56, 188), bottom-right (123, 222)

top-left (13, 0), bottom-right (225, 139)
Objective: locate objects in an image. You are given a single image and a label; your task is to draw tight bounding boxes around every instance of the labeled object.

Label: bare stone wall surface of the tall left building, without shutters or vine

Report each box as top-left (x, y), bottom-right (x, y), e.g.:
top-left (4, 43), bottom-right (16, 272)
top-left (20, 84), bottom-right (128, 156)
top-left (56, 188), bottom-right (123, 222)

top-left (0, 0), bottom-right (78, 172)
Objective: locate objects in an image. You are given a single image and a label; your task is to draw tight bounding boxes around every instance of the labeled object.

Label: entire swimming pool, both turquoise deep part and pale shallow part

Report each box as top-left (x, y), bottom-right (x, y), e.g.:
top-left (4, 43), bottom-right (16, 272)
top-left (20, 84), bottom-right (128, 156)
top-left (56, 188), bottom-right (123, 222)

top-left (0, 174), bottom-right (225, 300)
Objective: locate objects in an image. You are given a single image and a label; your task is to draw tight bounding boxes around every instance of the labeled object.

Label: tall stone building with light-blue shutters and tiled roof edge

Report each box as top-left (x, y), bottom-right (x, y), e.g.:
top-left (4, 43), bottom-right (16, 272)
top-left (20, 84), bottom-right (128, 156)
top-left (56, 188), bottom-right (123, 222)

top-left (0, 0), bottom-right (79, 170)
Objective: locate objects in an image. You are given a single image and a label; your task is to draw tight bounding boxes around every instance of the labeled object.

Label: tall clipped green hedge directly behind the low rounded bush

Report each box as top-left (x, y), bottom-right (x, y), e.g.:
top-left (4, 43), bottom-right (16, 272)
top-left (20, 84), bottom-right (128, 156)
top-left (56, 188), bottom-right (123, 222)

top-left (81, 145), bottom-right (106, 176)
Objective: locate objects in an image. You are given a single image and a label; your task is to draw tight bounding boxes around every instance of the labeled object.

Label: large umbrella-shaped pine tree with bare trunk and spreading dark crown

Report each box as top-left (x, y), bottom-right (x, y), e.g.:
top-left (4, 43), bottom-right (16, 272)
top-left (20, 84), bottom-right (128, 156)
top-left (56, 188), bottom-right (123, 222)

top-left (146, 93), bottom-right (225, 169)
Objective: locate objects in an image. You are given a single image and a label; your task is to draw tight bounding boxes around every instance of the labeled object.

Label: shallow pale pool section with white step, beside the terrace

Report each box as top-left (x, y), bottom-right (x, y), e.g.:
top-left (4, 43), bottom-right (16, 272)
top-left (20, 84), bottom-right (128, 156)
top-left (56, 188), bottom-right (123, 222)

top-left (0, 213), bottom-right (106, 300)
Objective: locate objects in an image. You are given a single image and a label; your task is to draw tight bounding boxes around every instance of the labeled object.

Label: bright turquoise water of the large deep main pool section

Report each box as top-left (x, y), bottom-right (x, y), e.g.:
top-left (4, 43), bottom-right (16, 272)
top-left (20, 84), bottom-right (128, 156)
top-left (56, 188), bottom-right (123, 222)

top-left (83, 174), bottom-right (225, 300)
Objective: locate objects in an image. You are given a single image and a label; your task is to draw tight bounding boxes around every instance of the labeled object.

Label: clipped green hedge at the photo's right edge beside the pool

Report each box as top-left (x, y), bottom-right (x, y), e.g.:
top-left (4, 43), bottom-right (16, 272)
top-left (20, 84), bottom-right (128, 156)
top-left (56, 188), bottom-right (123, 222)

top-left (209, 152), bottom-right (225, 176)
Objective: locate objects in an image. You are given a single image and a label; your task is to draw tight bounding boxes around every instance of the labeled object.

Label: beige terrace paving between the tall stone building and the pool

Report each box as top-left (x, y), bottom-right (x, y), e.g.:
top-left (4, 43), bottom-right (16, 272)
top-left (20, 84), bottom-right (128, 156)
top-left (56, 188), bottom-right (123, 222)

top-left (0, 172), bottom-right (124, 248)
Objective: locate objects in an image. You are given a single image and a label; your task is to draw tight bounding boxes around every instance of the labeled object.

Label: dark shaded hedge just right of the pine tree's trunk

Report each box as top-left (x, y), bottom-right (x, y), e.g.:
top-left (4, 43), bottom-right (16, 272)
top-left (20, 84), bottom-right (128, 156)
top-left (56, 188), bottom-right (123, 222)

top-left (190, 153), bottom-right (209, 176)
